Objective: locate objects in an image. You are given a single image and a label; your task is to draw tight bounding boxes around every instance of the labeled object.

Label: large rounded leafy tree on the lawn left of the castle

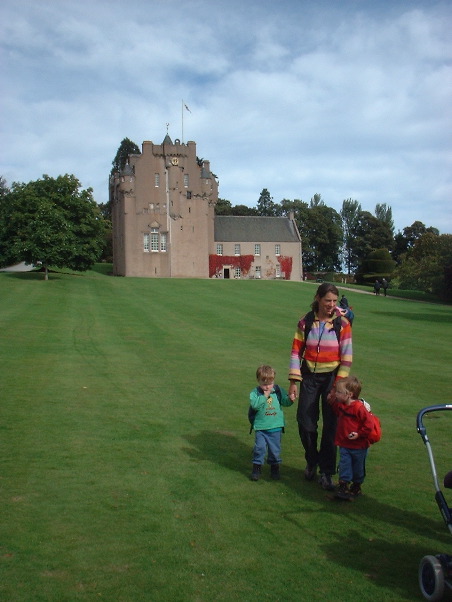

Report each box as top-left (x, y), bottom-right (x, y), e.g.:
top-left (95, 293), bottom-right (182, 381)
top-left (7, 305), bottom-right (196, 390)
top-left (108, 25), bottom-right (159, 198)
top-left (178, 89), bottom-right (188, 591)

top-left (0, 174), bottom-right (106, 280)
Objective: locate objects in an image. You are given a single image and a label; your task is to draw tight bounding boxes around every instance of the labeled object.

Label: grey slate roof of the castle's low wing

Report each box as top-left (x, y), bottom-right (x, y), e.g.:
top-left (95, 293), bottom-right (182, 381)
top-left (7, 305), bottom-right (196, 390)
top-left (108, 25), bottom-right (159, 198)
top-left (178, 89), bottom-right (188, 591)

top-left (214, 215), bottom-right (300, 243)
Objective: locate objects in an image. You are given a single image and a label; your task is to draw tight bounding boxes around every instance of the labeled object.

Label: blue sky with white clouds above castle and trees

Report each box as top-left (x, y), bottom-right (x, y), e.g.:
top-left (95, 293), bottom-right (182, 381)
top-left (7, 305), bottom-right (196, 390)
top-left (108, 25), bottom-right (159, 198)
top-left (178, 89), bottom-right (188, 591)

top-left (0, 0), bottom-right (452, 233)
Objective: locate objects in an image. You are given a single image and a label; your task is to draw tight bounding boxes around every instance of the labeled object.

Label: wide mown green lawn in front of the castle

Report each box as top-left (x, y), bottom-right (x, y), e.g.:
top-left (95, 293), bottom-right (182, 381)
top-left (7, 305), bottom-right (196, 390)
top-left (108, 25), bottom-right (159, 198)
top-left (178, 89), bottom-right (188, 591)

top-left (0, 266), bottom-right (452, 602)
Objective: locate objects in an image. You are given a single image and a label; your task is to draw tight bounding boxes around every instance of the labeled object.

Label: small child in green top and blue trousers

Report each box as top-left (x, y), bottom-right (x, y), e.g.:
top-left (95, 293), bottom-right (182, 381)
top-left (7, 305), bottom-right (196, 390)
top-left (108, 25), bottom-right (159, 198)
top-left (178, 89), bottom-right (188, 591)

top-left (249, 365), bottom-right (295, 481)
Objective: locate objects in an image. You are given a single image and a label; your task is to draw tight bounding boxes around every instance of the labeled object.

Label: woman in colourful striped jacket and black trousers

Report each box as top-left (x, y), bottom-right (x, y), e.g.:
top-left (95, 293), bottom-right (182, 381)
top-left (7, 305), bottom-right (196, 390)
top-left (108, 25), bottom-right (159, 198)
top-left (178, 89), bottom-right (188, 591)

top-left (289, 282), bottom-right (352, 490)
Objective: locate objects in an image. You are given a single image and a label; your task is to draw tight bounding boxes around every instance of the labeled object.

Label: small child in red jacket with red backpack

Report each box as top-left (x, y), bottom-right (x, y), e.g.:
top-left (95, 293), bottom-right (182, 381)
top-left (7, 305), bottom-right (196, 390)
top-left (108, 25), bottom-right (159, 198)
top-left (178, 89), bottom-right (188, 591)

top-left (329, 376), bottom-right (373, 500)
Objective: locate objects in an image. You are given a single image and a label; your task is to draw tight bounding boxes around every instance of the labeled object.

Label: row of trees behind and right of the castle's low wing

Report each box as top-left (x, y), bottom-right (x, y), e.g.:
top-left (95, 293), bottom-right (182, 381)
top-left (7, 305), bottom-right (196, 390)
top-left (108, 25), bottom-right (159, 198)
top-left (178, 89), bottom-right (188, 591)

top-left (215, 188), bottom-right (452, 300)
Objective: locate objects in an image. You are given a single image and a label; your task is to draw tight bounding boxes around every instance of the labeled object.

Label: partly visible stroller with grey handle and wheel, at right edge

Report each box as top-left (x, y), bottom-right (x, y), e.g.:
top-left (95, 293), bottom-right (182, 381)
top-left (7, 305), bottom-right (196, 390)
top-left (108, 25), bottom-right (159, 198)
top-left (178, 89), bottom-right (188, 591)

top-left (416, 404), bottom-right (452, 602)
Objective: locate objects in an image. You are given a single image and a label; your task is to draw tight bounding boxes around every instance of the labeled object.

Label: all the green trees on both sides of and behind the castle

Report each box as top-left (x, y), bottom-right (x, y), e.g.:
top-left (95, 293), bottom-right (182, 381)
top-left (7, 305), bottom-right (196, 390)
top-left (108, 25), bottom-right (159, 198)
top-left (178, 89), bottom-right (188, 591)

top-left (0, 138), bottom-right (452, 300)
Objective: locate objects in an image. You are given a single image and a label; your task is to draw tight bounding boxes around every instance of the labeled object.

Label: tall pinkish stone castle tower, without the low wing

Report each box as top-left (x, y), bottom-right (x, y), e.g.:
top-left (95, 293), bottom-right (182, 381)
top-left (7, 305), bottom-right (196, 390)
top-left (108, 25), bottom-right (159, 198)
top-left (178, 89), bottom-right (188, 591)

top-left (110, 134), bottom-right (218, 278)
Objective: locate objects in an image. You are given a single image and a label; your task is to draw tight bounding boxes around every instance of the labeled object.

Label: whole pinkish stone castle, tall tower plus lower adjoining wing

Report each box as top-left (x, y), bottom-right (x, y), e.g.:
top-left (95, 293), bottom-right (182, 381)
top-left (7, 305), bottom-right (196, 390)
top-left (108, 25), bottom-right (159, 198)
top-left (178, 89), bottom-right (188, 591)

top-left (110, 135), bottom-right (302, 280)
